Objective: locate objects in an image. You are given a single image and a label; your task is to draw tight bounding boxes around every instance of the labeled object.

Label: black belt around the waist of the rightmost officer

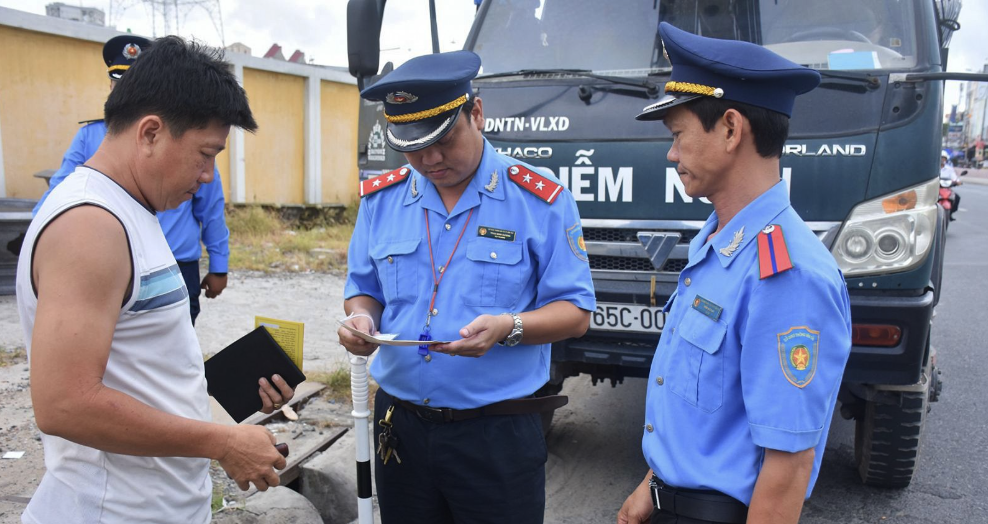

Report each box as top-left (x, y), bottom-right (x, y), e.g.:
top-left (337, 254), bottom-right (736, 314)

top-left (648, 475), bottom-right (748, 524)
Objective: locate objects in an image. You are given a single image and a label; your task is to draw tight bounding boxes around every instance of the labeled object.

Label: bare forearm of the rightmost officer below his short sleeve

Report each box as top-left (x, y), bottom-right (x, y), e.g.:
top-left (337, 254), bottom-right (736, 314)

top-left (748, 448), bottom-right (815, 524)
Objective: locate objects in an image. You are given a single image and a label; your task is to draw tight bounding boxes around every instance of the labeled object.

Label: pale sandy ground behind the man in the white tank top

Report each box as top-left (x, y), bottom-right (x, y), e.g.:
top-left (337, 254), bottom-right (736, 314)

top-left (0, 273), bottom-right (348, 524)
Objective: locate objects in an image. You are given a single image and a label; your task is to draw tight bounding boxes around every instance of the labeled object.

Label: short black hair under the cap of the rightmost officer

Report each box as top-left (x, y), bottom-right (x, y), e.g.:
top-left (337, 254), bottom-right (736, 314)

top-left (683, 97), bottom-right (789, 158)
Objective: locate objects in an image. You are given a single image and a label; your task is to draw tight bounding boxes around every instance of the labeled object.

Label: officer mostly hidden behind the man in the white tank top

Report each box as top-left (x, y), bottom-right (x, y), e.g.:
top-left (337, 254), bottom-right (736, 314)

top-left (33, 35), bottom-right (230, 324)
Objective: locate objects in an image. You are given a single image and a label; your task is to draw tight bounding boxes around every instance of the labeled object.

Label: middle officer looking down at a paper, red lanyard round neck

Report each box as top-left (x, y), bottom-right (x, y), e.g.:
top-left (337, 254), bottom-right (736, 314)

top-left (339, 51), bottom-right (595, 524)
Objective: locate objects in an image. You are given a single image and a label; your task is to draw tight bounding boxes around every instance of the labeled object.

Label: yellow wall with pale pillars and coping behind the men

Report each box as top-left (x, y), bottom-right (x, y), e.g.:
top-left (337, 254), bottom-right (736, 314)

top-left (0, 8), bottom-right (360, 205)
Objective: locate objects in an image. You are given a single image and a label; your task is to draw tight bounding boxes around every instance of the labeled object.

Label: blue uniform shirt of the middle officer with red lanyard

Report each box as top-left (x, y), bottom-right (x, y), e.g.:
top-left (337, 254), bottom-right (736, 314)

top-left (344, 140), bottom-right (596, 409)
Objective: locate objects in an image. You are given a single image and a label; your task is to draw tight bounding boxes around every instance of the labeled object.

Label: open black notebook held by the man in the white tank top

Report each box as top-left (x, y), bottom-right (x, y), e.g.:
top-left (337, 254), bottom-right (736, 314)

top-left (205, 326), bottom-right (305, 423)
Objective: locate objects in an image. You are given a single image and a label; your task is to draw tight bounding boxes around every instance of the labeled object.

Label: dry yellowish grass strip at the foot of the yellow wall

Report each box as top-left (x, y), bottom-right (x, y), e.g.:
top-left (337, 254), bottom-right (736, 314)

top-left (226, 202), bottom-right (358, 273)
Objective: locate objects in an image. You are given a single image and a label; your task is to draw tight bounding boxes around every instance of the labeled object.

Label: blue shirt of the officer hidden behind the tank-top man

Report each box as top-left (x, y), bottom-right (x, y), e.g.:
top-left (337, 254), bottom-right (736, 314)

top-left (33, 120), bottom-right (230, 273)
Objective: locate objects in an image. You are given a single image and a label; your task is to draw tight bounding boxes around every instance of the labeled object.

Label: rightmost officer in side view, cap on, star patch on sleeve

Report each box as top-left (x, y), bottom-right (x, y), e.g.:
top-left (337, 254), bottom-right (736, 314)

top-left (617, 23), bottom-right (851, 523)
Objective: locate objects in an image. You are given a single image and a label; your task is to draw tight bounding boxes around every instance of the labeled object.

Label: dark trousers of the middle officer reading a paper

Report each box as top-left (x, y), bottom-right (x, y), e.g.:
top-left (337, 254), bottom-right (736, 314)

top-left (373, 389), bottom-right (547, 524)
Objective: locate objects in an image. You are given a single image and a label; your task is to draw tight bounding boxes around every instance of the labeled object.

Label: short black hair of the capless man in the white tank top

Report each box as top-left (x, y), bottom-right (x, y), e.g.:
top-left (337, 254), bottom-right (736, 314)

top-left (103, 36), bottom-right (257, 137)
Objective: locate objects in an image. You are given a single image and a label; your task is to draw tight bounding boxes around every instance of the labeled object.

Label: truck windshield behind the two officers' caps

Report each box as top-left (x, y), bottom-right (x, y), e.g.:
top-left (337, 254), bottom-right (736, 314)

top-left (469, 0), bottom-right (921, 76)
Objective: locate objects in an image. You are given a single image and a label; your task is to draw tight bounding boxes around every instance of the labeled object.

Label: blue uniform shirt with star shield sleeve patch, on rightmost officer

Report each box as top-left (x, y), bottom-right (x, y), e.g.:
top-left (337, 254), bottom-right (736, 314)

top-left (642, 182), bottom-right (851, 504)
